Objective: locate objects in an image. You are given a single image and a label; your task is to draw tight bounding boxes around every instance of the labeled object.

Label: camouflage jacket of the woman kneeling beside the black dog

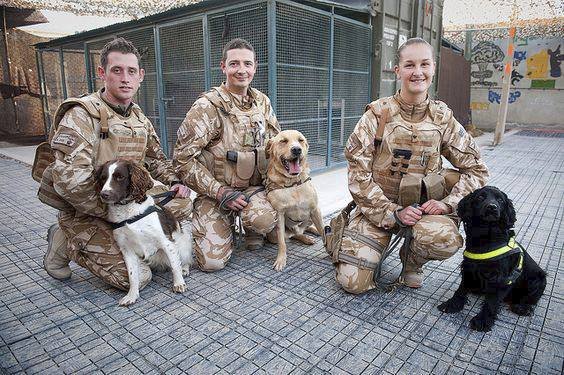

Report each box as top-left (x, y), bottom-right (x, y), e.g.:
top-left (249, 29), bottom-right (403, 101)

top-left (345, 94), bottom-right (488, 229)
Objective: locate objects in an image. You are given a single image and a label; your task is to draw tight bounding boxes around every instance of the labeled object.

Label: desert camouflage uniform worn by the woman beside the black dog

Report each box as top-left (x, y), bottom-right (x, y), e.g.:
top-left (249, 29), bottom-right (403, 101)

top-left (336, 93), bottom-right (488, 293)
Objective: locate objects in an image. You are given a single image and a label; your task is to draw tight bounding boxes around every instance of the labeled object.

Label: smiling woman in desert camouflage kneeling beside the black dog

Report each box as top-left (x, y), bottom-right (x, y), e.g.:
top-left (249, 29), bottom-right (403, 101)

top-left (334, 38), bottom-right (488, 294)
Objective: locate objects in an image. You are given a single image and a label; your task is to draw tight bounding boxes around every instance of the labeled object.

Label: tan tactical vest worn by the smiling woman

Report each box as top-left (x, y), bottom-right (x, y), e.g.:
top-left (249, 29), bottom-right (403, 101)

top-left (367, 97), bottom-right (454, 207)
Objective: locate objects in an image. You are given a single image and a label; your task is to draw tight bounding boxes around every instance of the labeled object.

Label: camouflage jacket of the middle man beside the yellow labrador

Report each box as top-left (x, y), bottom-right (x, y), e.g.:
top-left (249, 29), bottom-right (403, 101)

top-left (173, 85), bottom-right (280, 199)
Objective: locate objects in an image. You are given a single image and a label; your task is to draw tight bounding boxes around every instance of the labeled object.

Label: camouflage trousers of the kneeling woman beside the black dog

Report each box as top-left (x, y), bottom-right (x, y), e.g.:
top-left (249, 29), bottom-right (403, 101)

top-left (335, 209), bottom-right (463, 294)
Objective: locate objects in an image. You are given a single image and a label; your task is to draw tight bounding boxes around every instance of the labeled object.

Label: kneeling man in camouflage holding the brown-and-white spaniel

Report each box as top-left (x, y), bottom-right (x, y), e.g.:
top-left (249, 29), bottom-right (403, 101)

top-left (39, 38), bottom-right (191, 290)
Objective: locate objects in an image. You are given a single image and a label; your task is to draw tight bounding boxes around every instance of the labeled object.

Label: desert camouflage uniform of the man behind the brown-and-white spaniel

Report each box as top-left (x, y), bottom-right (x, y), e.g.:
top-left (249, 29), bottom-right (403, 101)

top-left (48, 92), bottom-right (191, 290)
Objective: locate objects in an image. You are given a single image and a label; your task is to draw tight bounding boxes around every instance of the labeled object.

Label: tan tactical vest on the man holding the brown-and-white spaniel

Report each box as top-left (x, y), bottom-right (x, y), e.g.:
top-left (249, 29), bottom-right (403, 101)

top-left (32, 92), bottom-right (149, 211)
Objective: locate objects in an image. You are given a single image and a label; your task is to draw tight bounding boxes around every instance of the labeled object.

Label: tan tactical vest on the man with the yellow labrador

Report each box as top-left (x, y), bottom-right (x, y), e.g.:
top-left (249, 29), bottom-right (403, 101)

top-left (198, 87), bottom-right (272, 188)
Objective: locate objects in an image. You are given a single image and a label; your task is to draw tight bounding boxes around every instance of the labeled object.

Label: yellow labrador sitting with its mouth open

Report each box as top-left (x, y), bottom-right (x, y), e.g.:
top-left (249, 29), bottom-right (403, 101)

top-left (266, 130), bottom-right (324, 271)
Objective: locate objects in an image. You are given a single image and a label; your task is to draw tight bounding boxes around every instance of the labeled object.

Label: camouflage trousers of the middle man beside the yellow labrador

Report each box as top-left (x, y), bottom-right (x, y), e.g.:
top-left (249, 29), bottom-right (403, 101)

top-left (192, 187), bottom-right (276, 272)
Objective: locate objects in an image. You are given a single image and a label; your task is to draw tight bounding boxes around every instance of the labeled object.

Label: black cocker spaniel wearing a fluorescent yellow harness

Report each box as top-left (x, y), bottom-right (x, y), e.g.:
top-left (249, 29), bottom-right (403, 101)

top-left (438, 186), bottom-right (546, 331)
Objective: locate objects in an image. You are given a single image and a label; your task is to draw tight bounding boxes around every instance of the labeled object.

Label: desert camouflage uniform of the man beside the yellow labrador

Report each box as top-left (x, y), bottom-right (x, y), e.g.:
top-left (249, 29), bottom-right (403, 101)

top-left (173, 85), bottom-right (280, 271)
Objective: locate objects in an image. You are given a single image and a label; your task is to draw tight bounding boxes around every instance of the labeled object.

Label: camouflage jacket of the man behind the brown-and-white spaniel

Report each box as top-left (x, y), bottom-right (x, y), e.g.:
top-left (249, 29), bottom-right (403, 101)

top-left (50, 92), bottom-right (180, 217)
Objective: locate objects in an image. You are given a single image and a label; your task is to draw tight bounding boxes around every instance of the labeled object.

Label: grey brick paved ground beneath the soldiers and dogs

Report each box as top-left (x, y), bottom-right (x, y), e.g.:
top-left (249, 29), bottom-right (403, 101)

top-left (0, 131), bottom-right (564, 374)
